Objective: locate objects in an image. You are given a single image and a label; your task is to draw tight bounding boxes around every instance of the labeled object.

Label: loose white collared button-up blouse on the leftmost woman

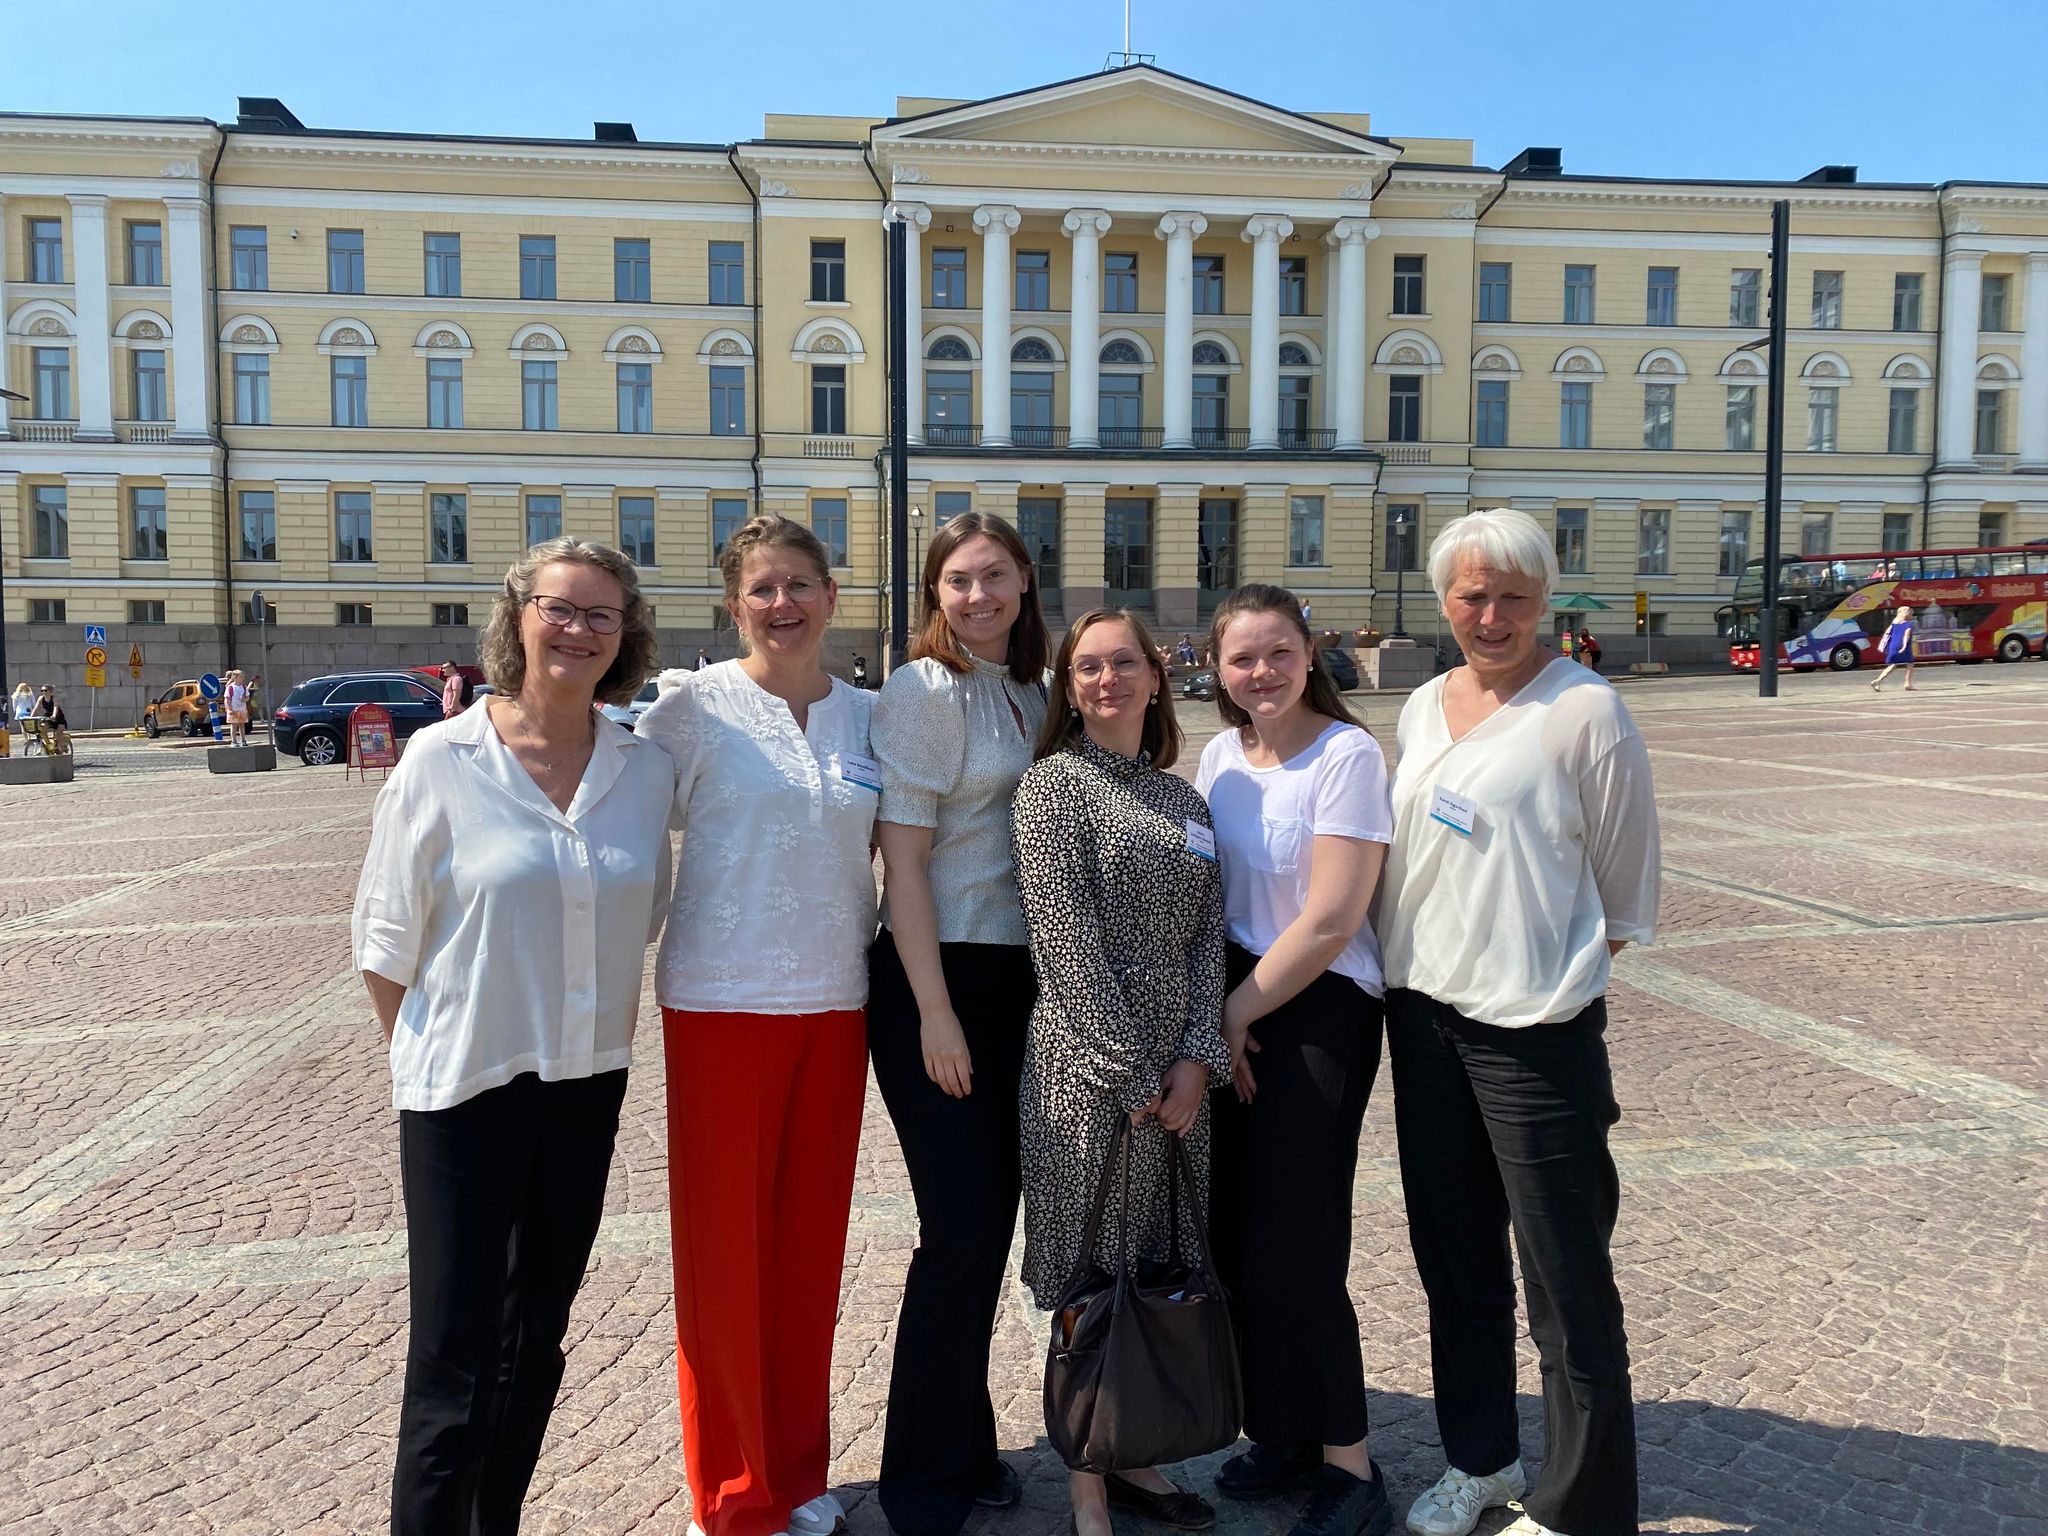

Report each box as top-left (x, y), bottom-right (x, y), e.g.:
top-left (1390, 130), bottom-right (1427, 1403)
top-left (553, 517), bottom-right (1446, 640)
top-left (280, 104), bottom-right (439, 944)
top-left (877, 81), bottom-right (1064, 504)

top-left (350, 709), bottom-right (676, 1110)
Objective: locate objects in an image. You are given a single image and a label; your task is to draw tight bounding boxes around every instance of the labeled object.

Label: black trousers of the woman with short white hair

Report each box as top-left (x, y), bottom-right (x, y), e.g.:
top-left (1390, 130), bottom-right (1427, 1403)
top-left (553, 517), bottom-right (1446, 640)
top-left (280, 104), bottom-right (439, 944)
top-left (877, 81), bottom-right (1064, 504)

top-left (1386, 991), bottom-right (1636, 1536)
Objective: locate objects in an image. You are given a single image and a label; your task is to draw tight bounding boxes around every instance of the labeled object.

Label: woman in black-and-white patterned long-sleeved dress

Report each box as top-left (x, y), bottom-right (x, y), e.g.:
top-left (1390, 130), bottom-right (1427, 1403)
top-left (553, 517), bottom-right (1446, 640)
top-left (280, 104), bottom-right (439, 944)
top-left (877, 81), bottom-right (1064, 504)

top-left (1012, 608), bottom-right (1231, 1536)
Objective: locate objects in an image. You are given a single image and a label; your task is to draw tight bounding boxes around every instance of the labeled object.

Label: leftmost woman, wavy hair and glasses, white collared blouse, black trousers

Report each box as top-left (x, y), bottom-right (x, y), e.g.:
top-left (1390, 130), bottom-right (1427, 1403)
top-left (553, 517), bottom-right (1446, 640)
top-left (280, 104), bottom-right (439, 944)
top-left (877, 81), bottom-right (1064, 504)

top-left (352, 539), bottom-right (676, 1536)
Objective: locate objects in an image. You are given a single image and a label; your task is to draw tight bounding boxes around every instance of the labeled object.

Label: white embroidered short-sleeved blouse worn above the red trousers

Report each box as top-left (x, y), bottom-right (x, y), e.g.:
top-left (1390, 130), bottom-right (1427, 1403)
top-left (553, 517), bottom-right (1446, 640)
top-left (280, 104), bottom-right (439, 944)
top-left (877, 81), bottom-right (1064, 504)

top-left (637, 662), bottom-right (881, 1014)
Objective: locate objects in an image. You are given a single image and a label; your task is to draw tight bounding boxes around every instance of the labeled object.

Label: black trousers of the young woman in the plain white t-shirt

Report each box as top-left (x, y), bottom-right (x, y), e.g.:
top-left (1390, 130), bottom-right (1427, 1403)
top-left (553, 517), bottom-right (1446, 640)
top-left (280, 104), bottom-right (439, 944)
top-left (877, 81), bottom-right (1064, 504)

top-left (1208, 944), bottom-right (1380, 1446)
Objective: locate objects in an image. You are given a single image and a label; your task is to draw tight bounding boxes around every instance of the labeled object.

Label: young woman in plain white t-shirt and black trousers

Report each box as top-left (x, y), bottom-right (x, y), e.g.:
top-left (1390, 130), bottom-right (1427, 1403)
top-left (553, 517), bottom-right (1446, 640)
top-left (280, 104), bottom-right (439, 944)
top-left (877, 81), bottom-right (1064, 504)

top-left (1194, 584), bottom-right (1393, 1536)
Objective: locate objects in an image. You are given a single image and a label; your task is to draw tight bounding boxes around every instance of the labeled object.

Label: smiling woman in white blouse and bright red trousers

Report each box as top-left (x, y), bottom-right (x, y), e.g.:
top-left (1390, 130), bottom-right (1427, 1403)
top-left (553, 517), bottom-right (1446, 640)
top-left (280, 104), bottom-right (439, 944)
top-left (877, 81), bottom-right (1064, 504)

top-left (639, 516), bottom-right (881, 1536)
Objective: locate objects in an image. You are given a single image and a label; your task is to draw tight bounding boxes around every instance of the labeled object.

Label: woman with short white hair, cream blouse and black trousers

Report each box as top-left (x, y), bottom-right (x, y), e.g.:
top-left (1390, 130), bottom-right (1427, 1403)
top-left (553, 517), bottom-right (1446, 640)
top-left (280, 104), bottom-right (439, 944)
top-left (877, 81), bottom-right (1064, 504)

top-left (1378, 508), bottom-right (1659, 1536)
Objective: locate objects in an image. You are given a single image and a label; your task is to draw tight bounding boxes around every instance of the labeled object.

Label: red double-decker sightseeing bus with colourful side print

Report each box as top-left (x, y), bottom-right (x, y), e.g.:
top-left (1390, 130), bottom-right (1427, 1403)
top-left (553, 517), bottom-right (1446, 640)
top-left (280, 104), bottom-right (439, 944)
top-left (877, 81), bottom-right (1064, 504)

top-left (1718, 543), bottom-right (2048, 672)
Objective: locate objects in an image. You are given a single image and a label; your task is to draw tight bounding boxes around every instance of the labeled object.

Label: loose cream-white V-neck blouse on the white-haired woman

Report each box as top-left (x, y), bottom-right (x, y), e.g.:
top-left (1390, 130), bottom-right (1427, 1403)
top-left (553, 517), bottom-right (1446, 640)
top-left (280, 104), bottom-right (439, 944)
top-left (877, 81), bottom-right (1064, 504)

top-left (1378, 657), bottom-right (1663, 1028)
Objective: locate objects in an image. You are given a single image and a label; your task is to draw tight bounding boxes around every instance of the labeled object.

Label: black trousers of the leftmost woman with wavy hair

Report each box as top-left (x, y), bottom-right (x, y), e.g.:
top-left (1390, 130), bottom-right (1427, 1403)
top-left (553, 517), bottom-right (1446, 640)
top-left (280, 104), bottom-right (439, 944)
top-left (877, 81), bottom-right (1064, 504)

top-left (391, 1071), bottom-right (627, 1536)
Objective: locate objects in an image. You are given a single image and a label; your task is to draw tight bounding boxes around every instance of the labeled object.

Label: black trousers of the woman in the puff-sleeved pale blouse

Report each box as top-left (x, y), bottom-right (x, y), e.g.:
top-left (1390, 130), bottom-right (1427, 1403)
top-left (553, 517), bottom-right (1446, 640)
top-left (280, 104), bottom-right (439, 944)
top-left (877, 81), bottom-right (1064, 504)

top-left (868, 930), bottom-right (1038, 1536)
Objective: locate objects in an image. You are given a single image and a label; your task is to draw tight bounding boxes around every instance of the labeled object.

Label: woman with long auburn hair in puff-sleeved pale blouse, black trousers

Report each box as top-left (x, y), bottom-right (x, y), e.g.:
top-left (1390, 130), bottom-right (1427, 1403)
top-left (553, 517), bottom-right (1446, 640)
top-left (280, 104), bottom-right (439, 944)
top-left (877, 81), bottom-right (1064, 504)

top-left (868, 512), bottom-right (1051, 1536)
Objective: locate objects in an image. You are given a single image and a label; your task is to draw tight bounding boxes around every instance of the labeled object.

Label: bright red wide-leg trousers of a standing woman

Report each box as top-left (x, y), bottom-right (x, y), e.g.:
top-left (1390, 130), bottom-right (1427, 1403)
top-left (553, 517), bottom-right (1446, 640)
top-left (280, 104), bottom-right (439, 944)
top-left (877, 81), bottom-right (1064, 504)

top-left (662, 1008), bottom-right (866, 1536)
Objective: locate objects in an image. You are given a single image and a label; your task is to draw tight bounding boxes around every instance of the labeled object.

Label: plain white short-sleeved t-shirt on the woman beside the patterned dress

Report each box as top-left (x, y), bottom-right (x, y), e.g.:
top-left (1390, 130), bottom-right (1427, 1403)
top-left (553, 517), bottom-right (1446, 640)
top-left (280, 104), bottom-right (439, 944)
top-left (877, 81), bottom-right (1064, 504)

top-left (1194, 721), bottom-right (1393, 997)
